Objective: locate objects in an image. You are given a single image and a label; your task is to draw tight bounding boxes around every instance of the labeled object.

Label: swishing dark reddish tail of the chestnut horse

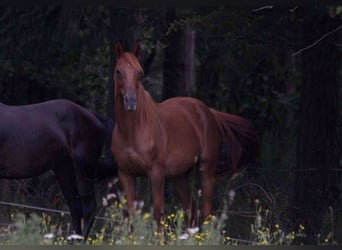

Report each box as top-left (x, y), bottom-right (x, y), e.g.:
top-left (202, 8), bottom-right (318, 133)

top-left (211, 109), bottom-right (259, 176)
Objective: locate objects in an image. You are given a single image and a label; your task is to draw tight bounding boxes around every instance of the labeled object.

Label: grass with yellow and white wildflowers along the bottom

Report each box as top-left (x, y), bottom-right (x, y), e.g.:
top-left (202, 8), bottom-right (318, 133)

top-left (0, 190), bottom-right (320, 246)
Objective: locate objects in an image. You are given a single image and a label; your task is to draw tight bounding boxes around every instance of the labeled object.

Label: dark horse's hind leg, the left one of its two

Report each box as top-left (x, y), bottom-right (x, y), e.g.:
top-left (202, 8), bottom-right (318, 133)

top-left (54, 161), bottom-right (82, 234)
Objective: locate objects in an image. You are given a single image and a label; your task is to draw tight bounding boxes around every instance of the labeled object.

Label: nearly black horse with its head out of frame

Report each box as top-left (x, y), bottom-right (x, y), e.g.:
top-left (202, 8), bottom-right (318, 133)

top-left (0, 100), bottom-right (115, 236)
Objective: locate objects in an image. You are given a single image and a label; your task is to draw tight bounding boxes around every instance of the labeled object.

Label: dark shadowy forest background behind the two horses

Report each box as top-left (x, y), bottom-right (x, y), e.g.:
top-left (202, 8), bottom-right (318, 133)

top-left (0, 6), bottom-right (342, 245)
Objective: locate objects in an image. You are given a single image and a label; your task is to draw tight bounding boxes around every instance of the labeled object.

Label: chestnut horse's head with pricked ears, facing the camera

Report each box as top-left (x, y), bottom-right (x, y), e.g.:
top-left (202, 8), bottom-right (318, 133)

top-left (114, 43), bottom-right (144, 111)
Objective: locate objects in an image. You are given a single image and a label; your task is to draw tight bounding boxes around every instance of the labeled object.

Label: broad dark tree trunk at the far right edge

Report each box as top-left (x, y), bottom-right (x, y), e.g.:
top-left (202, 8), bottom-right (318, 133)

top-left (292, 8), bottom-right (341, 243)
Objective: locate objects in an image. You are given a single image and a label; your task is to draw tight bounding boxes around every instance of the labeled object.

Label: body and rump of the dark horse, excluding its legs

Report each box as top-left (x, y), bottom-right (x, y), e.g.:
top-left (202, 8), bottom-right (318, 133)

top-left (0, 100), bottom-right (104, 178)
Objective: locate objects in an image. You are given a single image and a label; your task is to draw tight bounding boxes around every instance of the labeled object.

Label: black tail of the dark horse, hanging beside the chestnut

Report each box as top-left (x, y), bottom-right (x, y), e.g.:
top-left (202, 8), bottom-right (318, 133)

top-left (92, 111), bottom-right (118, 179)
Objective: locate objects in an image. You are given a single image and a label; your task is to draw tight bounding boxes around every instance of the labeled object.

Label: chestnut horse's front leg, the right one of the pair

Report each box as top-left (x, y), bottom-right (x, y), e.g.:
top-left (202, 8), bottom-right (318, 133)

top-left (150, 166), bottom-right (165, 231)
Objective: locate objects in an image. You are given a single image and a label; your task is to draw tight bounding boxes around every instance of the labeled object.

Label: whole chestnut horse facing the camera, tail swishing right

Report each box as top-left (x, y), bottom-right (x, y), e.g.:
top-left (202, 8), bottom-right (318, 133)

top-left (112, 43), bottom-right (258, 229)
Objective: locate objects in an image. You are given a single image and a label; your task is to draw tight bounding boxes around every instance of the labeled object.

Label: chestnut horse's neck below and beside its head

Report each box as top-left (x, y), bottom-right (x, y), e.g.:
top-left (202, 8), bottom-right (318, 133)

top-left (115, 89), bottom-right (160, 137)
